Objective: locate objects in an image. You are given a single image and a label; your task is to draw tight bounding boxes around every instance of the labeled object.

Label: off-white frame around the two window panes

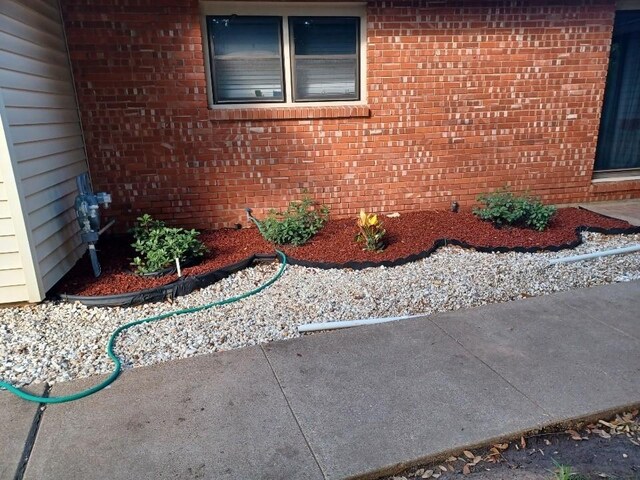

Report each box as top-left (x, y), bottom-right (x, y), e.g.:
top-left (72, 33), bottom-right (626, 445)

top-left (200, 1), bottom-right (367, 110)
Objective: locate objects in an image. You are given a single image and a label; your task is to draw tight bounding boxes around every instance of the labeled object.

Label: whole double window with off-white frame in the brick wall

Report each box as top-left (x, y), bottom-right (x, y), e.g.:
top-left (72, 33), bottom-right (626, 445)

top-left (201, 2), bottom-right (365, 107)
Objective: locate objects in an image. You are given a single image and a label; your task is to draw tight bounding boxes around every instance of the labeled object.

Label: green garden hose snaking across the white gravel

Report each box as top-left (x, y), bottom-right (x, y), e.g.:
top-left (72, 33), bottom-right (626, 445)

top-left (0, 250), bottom-right (287, 403)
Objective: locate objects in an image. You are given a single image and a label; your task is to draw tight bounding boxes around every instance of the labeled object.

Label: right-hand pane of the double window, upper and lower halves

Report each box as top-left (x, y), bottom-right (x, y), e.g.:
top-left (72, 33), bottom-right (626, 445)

top-left (289, 17), bottom-right (360, 101)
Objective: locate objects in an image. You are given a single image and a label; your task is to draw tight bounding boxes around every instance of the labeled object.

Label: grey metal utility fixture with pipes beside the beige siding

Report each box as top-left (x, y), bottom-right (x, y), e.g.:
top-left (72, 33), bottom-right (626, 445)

top-left (75, 173), bottom-right (114, 277)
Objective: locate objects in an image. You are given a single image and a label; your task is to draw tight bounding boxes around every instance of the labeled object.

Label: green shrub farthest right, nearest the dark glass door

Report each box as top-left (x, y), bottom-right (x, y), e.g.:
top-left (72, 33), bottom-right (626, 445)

top-left (473, 188), bottom-right (556, 231)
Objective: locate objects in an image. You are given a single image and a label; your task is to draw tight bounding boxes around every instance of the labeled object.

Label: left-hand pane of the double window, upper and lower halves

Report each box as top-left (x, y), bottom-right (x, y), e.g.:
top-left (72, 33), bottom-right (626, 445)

top-left (209, 16), bottom-right (284, 102)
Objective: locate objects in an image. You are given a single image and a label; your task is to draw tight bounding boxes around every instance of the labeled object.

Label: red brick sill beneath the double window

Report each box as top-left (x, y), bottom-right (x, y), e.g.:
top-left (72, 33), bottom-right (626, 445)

top-left (209, 104), bottom-right (371, 121)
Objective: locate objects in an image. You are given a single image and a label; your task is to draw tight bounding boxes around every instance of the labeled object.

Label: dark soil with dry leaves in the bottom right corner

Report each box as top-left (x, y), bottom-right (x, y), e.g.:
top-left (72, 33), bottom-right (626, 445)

top-left (384, 410), bottom-right (640, 480)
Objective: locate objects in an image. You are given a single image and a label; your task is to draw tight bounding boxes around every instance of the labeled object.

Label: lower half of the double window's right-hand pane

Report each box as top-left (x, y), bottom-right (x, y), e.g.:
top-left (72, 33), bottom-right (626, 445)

top-left (295, 57), bottom-right (357, 100)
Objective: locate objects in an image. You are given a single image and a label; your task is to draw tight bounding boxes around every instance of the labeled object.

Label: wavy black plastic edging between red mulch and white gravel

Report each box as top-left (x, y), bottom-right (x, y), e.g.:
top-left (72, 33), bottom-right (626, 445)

top-left (59, 222), bottom-right (640, 307)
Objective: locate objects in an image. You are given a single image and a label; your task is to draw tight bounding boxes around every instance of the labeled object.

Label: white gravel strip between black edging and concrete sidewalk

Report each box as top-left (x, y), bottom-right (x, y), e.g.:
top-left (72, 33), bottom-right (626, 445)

top-left (0, 233), bottom-right (640, 385)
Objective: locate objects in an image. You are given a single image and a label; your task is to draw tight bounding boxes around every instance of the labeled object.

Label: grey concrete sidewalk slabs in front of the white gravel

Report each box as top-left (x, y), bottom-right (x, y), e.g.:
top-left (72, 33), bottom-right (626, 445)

top-left (0, 282), bottom-right (640, 480)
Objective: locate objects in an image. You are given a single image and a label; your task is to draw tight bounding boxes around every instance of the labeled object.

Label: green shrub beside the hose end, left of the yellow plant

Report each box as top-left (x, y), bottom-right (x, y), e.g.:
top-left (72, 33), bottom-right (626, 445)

top-left (259, 195), bottom-right (329, 246)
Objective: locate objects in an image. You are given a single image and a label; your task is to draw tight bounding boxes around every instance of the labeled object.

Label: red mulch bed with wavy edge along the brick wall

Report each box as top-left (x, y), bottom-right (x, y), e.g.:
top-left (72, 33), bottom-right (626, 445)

top-left (56, 208), bottom-right (631, 296)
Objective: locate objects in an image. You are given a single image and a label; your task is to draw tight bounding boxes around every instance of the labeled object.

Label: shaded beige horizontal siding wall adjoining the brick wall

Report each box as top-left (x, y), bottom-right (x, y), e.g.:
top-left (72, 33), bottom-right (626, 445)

top-left (0, 0), bottom-right (87, 302)
